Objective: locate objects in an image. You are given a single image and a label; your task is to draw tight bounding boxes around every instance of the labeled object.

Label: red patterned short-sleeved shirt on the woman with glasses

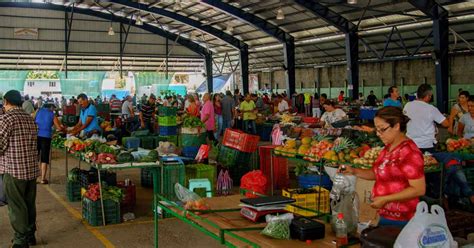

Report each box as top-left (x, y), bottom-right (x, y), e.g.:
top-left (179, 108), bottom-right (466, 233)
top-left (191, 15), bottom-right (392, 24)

top-left (372, 139), bottom-right (425, 221)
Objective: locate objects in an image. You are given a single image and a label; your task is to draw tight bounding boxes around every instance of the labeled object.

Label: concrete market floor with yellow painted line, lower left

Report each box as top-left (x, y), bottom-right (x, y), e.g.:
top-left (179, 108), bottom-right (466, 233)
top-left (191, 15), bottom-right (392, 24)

top-left (0, 151), bottom-right (223, 248)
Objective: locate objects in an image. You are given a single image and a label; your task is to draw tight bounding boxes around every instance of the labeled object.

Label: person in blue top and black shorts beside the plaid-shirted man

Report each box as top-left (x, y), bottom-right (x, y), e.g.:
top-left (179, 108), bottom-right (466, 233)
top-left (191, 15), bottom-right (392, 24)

top-left (35, 103), bottom-right (66, 184)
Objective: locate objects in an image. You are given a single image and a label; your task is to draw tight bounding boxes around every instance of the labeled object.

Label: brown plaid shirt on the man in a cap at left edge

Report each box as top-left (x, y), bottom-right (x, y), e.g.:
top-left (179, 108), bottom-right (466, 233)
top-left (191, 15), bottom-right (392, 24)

top-left (0, 108), bottom-right (39, 180)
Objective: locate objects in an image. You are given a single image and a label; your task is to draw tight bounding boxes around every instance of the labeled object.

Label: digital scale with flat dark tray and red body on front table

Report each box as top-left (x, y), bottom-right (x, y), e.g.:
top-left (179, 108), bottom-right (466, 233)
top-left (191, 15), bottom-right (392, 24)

top-left (240, 196), bottom-right (295, 222)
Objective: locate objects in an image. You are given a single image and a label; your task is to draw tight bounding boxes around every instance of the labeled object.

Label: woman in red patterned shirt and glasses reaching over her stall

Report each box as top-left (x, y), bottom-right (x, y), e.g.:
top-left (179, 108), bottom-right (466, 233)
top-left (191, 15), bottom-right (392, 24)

top-left (340, 107), bottom-right (426, 227)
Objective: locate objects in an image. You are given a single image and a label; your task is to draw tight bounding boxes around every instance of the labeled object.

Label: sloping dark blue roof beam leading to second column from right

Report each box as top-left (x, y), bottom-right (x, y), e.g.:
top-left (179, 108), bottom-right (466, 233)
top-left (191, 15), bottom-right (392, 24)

top-left (295, 0), bottom-right (357, 33)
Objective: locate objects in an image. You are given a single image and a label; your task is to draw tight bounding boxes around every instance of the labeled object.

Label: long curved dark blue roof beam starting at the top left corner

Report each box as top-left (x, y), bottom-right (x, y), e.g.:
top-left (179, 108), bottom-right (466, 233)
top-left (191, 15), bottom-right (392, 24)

top-left (0, 2), bottom-right (210, 56)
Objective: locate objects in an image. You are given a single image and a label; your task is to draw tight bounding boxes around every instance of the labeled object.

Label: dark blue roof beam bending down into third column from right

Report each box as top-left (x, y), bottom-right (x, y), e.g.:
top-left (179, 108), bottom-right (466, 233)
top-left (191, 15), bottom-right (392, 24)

top-left (201, 0), bottom-right (296, 93)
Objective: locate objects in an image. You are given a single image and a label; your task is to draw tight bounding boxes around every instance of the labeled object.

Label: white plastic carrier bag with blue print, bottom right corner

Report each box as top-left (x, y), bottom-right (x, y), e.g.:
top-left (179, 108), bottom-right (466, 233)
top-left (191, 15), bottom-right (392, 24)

top-left (393, 201), bottom-right (458, 248)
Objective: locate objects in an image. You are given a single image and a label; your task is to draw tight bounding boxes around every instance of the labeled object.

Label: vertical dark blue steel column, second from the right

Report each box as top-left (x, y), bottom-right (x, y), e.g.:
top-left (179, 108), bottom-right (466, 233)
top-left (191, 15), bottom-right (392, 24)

top-left (346, 32), bottom-right (359, 99)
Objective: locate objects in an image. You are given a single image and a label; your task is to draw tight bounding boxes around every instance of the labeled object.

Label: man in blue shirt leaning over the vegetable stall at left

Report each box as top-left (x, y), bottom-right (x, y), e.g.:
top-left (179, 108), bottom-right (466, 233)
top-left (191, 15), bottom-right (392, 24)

top-left (69, 93), bottom-right (101, 137)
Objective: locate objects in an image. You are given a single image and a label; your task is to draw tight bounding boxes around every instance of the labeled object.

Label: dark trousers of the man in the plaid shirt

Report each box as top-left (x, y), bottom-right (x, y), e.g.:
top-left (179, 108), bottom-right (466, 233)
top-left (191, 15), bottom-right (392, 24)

top-left (3, 174), bottom-right (36, 245)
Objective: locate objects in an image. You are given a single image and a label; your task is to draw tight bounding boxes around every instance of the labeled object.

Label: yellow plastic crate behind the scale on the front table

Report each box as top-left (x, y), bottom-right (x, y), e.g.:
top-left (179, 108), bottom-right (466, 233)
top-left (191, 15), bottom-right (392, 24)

top-left (282, 186), bottom-right (330, 217)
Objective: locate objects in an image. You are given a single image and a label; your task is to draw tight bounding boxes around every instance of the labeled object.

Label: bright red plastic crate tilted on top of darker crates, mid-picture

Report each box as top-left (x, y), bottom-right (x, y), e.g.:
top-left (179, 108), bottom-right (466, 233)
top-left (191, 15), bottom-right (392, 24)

top-left (222, 128), bottom-right (260, 153)
